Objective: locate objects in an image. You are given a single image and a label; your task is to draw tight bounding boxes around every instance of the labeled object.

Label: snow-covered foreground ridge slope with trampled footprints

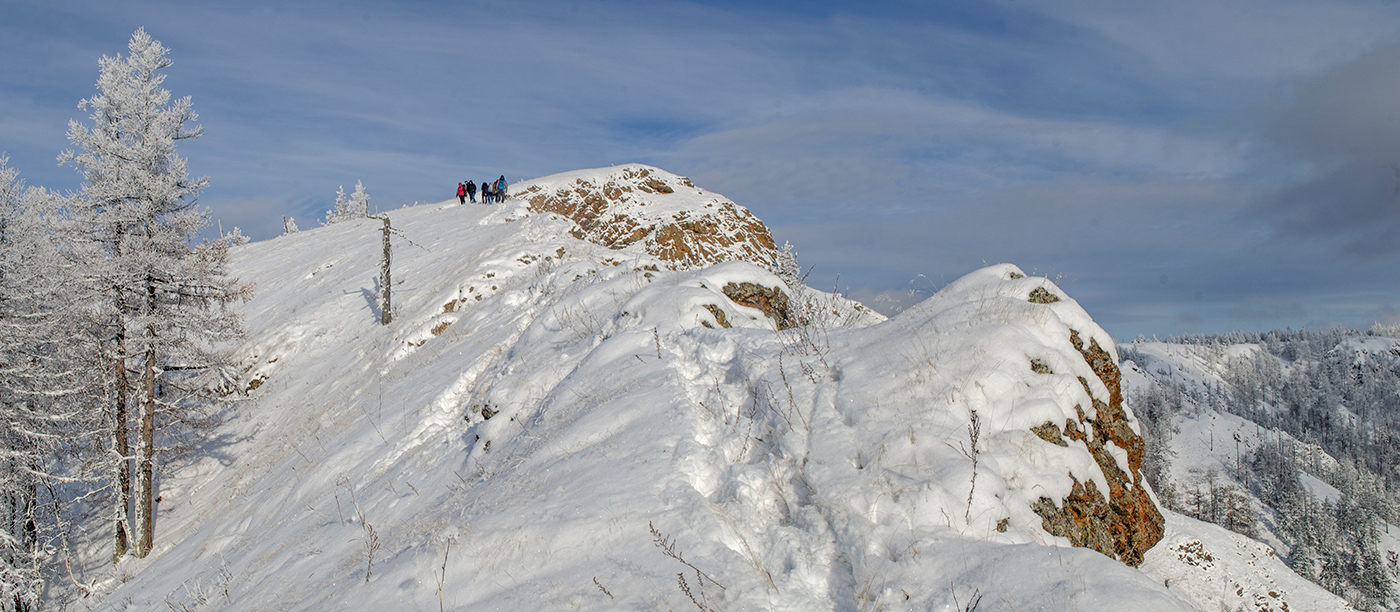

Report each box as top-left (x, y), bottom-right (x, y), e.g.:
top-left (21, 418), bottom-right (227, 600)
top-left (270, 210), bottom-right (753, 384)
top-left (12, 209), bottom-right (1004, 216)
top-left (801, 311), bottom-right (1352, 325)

top-left (60, 164), bottom-right (1327, 611)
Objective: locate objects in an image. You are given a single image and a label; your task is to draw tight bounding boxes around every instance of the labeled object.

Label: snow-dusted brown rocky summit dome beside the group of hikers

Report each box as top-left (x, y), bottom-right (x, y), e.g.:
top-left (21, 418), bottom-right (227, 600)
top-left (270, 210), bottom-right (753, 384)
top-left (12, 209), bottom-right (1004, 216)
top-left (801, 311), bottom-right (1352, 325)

top-left (511, 164), bottom-right (777, 269)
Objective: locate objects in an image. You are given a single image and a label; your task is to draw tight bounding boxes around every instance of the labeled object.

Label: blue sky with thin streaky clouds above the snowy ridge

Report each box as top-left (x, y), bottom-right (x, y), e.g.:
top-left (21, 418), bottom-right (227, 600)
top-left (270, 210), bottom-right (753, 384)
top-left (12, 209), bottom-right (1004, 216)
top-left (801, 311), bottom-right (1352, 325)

top-left (0, 0), bottom-right (1400, 339)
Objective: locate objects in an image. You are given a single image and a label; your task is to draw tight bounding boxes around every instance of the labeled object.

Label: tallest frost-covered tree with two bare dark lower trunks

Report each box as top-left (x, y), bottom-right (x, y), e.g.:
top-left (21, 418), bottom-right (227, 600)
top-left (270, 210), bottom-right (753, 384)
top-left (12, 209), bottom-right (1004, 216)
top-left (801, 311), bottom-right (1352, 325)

top-left (59, 29), bottom-right (245, 557)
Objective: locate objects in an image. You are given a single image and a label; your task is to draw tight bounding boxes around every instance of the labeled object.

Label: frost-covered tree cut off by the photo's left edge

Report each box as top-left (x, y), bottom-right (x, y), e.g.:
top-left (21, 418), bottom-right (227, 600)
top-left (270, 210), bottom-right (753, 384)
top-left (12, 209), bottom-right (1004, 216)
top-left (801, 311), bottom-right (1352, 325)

top-left (0, 157), bottom-right (95, 611)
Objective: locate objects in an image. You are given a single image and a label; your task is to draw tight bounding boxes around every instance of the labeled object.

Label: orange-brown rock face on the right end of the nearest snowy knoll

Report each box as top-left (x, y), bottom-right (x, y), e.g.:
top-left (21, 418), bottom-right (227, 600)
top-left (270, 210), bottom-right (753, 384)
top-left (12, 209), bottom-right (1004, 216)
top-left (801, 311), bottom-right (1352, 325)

top-left (1032, 331), bottom-right (1165, 566)
